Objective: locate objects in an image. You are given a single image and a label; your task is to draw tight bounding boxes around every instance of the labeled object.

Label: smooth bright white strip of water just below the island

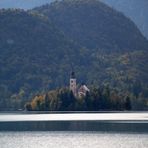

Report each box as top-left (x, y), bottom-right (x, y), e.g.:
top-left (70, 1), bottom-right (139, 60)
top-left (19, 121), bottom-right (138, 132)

top-left (0, 112), bottom-right (148, 122)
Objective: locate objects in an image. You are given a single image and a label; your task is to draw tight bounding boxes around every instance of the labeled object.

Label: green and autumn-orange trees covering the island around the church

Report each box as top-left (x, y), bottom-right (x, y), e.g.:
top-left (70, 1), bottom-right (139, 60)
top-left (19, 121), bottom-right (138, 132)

top-left (25, 86), bottom-right (132, 111)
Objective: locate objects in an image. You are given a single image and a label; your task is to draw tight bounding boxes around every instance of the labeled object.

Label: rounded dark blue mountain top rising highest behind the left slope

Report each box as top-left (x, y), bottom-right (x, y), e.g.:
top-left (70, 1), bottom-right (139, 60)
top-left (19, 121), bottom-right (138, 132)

top-left (34, 0), bottom-right (148, 52)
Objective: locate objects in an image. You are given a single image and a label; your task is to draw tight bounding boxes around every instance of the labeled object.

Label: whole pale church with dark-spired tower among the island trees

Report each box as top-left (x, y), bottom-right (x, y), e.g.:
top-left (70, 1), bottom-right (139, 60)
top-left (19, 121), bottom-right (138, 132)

top-left (70, 72), bottom-right (90, 97)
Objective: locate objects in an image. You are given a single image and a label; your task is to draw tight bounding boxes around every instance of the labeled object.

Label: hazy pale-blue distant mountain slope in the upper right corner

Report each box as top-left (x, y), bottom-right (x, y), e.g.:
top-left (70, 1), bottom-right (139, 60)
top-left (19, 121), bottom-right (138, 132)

top-left (101, 0), bottom-right (148, 38)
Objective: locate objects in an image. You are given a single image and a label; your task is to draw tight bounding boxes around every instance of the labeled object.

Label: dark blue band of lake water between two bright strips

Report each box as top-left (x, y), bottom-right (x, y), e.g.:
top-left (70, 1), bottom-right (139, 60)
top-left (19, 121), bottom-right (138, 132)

top-left (0, 121), bottom-right (148, 133)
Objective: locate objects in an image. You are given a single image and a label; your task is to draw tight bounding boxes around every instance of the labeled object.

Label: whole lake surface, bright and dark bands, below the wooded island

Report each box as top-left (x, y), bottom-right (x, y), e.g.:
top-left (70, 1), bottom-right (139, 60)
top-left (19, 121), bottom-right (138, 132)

top-left (0, 112), bottom-right (148, 148)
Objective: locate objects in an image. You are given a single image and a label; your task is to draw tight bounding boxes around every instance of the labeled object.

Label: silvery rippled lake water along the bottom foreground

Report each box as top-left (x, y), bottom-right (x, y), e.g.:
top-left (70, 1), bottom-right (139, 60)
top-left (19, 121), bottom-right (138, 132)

top-left (0, 132), bottom-right (148, 148)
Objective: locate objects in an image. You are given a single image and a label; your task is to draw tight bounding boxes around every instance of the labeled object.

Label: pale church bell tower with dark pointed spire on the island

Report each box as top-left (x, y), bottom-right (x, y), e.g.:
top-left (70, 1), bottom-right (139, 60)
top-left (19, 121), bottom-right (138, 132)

top-left (70, 72), bottom-right (77, 96)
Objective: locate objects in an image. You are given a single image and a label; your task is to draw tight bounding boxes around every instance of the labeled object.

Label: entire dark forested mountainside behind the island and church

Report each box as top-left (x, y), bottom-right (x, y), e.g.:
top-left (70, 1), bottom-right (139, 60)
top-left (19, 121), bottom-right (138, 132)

top-left (0, 0), bottom-right (148, 110)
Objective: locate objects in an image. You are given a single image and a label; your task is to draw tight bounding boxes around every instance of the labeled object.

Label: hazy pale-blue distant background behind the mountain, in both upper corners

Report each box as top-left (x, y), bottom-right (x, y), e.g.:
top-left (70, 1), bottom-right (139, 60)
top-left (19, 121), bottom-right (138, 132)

top-left (0, 0), bottom-right (148, 38)
